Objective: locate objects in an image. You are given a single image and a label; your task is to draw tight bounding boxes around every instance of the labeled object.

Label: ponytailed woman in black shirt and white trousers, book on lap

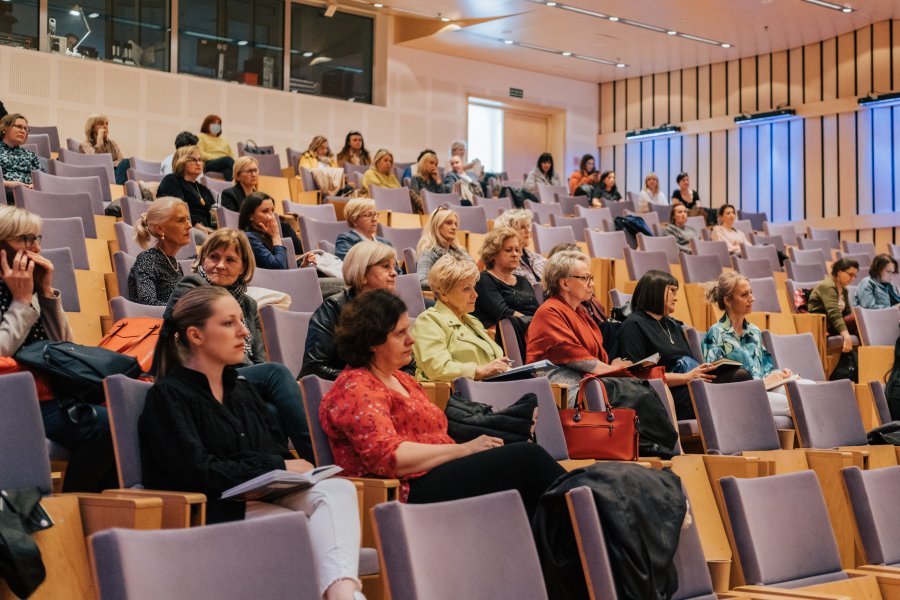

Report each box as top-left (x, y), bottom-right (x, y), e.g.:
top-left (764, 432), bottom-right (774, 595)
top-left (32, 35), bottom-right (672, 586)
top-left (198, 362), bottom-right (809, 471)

top-left (139, 286), bottom-right (361, 600)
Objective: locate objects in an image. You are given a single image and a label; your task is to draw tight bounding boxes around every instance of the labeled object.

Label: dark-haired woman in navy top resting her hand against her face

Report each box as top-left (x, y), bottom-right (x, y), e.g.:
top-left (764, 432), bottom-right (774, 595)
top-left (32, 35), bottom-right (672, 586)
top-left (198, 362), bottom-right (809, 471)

top-left (238, 192), bottom-right (316, 269)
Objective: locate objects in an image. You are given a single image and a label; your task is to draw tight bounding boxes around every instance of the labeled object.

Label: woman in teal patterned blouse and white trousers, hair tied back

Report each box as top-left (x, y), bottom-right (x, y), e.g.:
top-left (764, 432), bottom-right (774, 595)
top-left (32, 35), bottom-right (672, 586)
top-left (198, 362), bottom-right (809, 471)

top-left (703, 271), bottom-right (806, 417)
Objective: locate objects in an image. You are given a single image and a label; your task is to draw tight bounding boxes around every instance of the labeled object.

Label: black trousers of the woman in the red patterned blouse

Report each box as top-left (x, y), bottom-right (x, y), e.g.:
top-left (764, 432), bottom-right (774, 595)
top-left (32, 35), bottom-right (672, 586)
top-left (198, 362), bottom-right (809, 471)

top-left (409, 442), bottom-right (565, 521)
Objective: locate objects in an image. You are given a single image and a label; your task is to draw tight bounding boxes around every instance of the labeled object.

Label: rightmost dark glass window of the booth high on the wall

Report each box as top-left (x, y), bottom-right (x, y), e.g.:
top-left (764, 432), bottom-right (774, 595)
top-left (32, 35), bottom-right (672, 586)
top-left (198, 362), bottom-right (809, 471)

top-left (290, 4), bottom-right (374, 104)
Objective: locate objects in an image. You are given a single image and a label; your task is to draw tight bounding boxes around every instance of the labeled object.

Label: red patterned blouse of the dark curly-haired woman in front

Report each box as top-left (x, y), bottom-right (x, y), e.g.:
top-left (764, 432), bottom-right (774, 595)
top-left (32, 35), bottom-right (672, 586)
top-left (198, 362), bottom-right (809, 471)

top-left (319, 367), bottom-right (455, 502)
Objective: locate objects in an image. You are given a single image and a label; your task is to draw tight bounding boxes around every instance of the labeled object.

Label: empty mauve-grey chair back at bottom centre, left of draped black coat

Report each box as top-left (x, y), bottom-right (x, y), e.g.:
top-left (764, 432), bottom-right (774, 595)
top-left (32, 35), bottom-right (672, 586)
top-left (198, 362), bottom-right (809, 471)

top-left (374, 490), bottom-right (547, 600)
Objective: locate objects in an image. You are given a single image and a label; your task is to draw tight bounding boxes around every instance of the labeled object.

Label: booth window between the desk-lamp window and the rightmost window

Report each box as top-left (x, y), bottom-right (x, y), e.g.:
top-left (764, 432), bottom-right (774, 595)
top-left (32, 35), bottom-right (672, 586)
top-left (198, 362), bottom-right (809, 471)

top-left (178, 0), bottom-right (284, 89)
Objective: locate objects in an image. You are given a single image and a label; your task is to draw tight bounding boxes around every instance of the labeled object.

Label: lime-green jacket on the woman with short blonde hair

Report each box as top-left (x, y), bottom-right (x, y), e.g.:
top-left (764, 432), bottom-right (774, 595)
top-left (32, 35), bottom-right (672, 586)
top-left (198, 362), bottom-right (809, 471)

top-left (412, 300), bottom-right (503, 381)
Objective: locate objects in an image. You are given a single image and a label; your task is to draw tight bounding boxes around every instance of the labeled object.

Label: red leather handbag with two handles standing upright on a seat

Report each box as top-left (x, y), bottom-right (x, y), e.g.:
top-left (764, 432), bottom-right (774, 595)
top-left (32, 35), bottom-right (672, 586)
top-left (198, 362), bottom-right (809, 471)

top-left (559, 376), bottom-right (638, 460)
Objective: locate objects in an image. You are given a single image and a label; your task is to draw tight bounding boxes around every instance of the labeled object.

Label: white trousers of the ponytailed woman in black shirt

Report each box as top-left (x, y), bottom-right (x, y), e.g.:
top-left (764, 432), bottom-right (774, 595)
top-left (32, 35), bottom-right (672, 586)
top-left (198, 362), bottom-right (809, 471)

top-left (245, 477), bottom-right (361, 596)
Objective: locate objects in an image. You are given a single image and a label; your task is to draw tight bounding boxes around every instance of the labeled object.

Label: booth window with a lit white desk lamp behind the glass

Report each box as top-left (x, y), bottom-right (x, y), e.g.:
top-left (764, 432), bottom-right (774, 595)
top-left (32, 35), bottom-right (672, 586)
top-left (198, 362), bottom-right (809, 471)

top-left (47, 0), bottom-right (169, 71)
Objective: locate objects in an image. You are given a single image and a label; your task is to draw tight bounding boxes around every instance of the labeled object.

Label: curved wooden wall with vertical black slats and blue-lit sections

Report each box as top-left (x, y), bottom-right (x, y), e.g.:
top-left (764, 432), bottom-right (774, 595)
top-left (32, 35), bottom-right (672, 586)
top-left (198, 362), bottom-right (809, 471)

top-left (598, 20), bottom-right (900, 245)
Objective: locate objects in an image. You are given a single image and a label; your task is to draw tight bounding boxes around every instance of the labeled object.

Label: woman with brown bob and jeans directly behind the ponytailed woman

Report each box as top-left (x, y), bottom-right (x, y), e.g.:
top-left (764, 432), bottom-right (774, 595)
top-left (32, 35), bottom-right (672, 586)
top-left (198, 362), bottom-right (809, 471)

top-left (153, 227), bottom-right (314, 460)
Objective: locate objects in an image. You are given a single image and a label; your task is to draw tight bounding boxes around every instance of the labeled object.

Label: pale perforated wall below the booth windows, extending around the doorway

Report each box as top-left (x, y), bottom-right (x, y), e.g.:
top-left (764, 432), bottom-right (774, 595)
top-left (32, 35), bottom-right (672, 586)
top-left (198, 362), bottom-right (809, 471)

top-left (0, 39), bottom-right (599, 171)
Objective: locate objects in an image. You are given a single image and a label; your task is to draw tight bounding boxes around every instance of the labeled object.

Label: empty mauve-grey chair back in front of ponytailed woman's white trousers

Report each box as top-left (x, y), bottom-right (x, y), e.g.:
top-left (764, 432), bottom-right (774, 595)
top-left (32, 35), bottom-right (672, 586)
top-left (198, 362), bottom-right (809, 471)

top-left (91, 513), bottom-right (321, 600)
